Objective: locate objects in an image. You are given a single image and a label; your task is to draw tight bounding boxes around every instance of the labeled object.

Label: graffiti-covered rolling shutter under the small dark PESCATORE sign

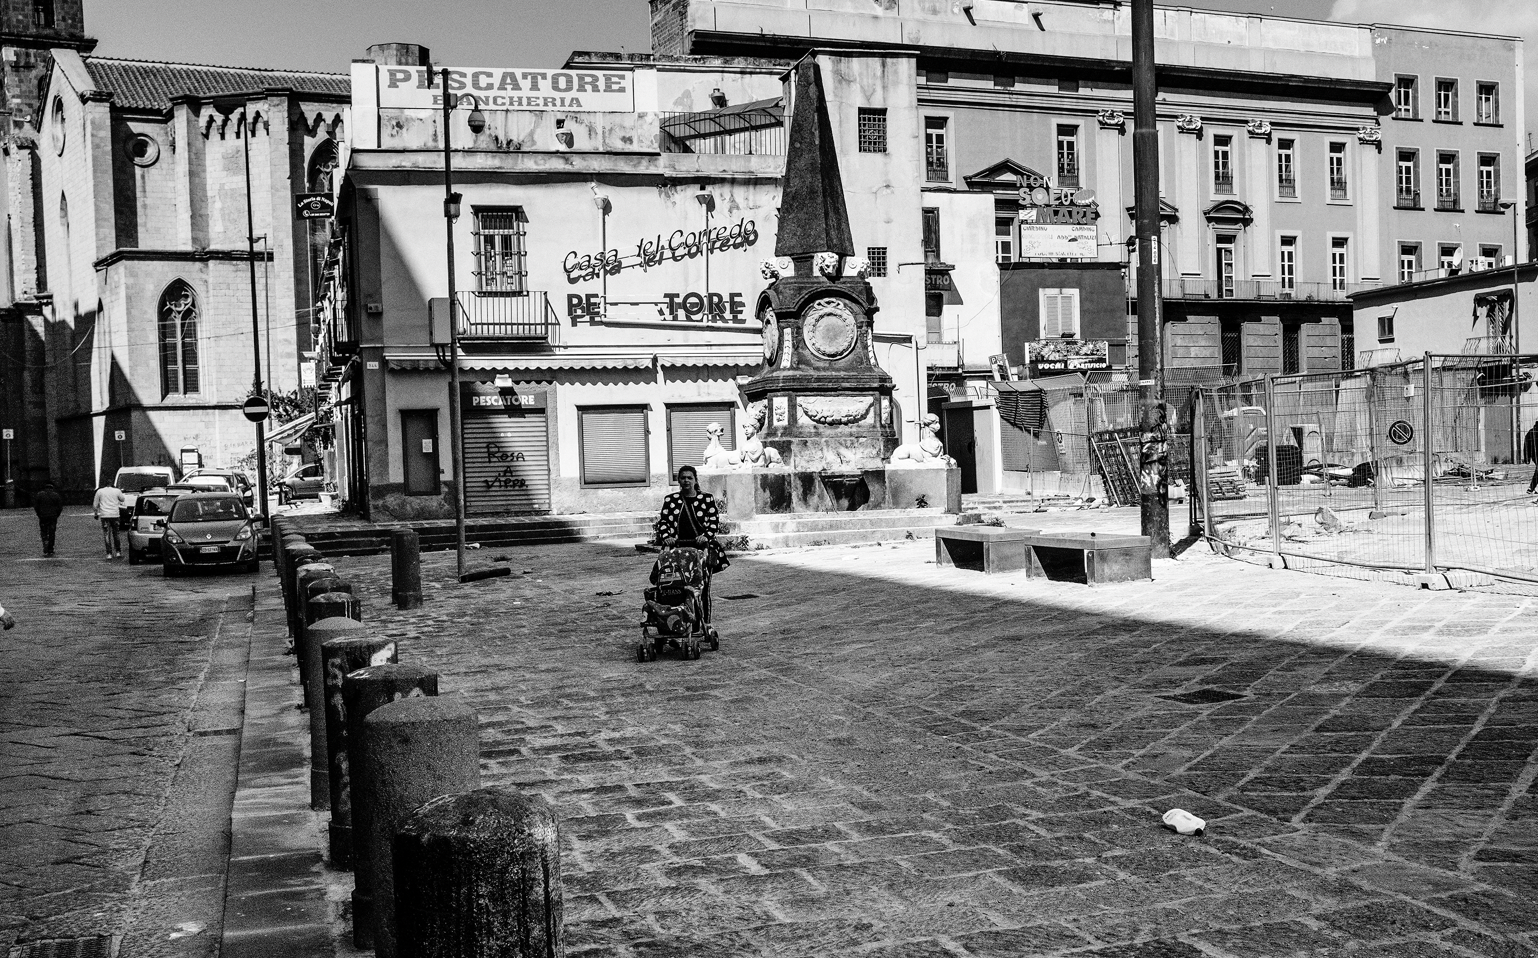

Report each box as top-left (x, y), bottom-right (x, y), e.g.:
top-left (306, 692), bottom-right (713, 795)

top-left (464, 415), bottom-right (551, 515)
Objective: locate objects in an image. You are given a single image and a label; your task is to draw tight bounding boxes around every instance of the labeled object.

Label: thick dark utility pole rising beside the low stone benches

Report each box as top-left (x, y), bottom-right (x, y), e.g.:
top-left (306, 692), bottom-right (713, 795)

top-left (1132, 0), bottom-right (1168, 558)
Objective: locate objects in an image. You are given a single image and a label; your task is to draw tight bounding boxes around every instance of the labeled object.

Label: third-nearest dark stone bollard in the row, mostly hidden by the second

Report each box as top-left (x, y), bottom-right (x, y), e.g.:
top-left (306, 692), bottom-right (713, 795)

top-left (341, 666), bottom-right (438, 949)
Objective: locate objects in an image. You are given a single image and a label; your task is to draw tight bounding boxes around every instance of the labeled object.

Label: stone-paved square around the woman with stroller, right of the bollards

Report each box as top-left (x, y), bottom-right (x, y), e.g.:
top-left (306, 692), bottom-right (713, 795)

top-left (324, 541), bottom-right (1538, 958)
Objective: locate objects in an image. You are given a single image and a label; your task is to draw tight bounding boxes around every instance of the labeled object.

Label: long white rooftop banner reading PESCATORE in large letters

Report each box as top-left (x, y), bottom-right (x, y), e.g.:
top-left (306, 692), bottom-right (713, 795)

top-left (375, 66), bottom-right (635, 114)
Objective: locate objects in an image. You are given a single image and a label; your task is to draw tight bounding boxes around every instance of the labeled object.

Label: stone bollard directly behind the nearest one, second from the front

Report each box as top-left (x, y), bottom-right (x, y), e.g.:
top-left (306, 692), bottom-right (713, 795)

top-left (363, 695), bottom-right (480, 958)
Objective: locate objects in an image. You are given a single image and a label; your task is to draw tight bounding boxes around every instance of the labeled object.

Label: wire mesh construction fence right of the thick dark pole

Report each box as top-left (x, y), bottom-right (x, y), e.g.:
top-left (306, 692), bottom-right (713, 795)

top-left (1187, 355), bottom-right (1538, 586)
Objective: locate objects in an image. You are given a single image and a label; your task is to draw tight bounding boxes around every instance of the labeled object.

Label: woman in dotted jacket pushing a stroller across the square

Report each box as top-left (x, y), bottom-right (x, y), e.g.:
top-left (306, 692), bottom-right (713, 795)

top-left (637, 466), bottom-right (729, 661)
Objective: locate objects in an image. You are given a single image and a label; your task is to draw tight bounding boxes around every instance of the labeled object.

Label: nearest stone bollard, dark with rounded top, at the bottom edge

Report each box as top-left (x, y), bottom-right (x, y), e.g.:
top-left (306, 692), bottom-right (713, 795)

top-left (394, 789), bottom-right (566, 958)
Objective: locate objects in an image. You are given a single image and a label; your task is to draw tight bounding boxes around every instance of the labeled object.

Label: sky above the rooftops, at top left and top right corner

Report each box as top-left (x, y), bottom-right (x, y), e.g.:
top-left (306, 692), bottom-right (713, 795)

top-left (85, 0), bottom-right (1538, 134)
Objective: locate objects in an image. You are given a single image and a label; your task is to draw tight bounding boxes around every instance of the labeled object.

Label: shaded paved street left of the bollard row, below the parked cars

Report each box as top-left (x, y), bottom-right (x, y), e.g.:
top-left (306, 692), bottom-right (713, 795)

top-left (0, 509), bottom-right (251, 958)
